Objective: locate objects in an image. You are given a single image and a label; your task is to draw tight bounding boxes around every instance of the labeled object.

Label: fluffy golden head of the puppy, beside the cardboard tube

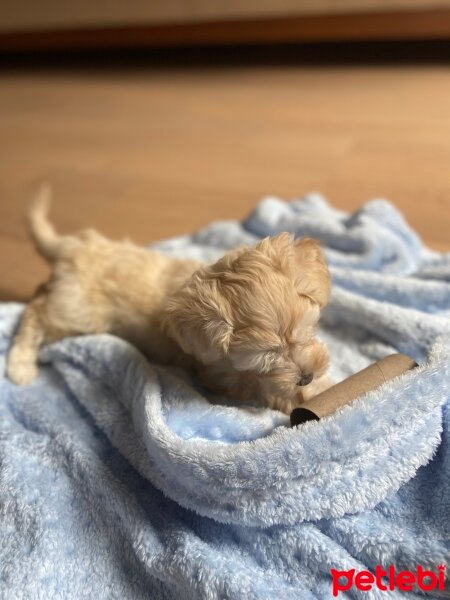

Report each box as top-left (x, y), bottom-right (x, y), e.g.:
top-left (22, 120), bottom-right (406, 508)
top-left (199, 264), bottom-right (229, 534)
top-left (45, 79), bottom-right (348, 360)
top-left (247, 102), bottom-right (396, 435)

top-left (166, 233), bottom-right (330, 395)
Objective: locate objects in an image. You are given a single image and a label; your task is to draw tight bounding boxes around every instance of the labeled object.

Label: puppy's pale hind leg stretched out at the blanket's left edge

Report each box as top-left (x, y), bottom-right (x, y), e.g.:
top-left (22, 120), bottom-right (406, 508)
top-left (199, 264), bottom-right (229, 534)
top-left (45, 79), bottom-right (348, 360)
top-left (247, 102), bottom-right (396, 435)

top-left (6, 296), bottom-right (46, 385)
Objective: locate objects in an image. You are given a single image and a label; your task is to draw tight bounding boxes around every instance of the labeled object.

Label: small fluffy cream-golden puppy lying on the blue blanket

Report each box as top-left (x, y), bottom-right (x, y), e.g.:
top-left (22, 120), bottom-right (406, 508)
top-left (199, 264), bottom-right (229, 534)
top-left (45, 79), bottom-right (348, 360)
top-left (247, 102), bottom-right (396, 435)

top-left (7, 188), bottom-right (330, 414)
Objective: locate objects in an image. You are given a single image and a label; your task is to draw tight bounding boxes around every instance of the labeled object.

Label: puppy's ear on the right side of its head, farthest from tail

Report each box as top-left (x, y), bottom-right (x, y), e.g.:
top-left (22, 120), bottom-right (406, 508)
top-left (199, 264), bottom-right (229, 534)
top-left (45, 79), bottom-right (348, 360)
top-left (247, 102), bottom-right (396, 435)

top-left (293, 238), bottom-right (331, 308)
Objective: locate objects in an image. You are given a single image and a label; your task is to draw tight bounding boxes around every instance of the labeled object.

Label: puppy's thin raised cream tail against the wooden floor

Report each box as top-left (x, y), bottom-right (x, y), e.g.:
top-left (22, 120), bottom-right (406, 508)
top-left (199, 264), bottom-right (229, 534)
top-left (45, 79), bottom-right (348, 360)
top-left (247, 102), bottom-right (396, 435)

top-left (28, 184), bottom-right (62, 262)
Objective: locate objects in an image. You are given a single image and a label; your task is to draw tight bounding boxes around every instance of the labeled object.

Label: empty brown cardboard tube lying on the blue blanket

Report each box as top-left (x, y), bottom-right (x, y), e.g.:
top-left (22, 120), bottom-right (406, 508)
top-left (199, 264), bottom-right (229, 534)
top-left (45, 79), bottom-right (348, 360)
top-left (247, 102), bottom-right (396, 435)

top-left (291, 354), bottom-right (417, 426)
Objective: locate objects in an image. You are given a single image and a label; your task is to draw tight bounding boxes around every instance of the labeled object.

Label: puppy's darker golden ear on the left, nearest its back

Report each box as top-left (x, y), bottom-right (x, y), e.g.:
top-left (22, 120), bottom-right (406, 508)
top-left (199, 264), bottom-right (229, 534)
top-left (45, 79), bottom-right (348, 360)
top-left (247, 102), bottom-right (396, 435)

top-left (164, 270), bottom-right (233, 364)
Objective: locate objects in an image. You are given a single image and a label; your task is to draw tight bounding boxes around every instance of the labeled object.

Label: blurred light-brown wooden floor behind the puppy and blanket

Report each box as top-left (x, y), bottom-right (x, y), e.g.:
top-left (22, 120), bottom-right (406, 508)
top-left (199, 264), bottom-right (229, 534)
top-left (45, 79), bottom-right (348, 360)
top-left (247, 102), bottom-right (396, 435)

top-left (0, 55), bottom-right (450, 299)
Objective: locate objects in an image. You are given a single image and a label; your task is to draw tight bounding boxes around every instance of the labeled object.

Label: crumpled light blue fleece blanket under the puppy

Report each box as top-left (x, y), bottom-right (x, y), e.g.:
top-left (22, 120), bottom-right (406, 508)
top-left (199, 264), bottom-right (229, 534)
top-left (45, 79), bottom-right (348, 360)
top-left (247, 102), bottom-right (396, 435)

top-left (0, 195), bottom-right (450, 600)
